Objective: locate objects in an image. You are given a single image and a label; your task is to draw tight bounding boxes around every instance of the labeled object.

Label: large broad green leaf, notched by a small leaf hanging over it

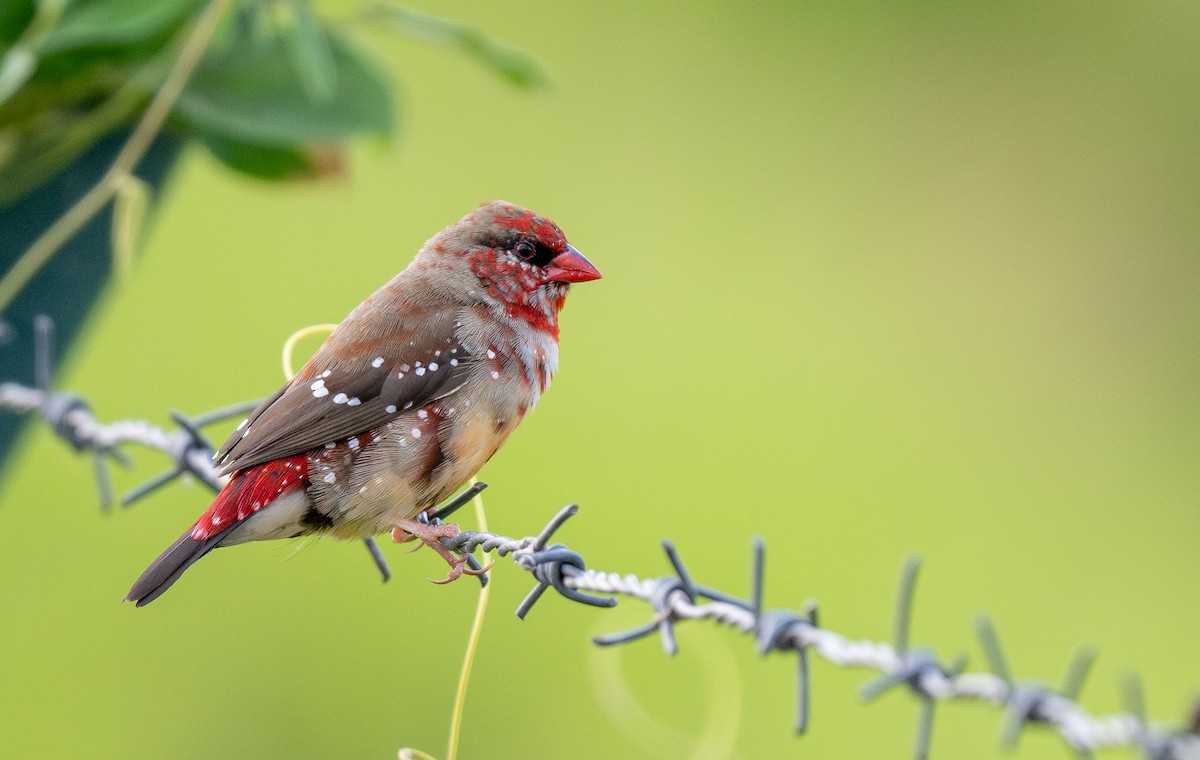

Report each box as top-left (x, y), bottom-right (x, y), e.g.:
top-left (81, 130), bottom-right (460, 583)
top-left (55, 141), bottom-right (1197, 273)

top-left (174, 36), bottom-right (392, 148)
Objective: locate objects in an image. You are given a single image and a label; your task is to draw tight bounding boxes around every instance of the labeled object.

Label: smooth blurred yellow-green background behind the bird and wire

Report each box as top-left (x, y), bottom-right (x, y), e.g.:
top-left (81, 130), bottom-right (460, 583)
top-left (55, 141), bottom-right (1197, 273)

top-left (0, 0), bottom-right (1200, 759)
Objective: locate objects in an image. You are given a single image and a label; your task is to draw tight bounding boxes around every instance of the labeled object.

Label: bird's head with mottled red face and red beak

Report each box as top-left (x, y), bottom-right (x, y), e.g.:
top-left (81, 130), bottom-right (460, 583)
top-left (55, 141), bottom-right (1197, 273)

top-left (418, 201), bottom-right (600, 333)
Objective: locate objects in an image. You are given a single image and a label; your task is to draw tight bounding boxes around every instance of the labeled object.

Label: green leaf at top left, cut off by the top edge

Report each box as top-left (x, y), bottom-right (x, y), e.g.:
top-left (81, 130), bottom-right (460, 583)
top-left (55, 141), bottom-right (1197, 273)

top-left (37, 0), bottom-right (202, 55)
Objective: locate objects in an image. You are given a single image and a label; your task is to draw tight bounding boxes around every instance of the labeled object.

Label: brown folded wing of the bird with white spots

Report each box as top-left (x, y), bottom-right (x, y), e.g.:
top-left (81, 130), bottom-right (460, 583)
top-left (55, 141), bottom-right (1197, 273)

top-left (216, 315), bottom-right (473, 474)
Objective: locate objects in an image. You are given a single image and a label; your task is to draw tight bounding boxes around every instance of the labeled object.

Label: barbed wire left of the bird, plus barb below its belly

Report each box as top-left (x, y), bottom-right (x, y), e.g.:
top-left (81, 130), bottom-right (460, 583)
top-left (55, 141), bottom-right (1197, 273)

top-left (0, 315), bottom-right (391, 582)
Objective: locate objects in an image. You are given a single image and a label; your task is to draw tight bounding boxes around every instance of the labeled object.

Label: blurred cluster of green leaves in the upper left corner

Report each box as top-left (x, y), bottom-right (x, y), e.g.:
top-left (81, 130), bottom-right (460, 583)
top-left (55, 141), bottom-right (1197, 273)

top-left (0, 0), bottom-right (542, 208)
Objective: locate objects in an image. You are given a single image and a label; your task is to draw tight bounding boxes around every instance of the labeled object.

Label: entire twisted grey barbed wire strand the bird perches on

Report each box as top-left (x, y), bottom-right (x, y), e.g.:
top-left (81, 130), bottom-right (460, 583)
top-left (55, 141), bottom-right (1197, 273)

top-left (0, 317), bottom-right (1200, 760)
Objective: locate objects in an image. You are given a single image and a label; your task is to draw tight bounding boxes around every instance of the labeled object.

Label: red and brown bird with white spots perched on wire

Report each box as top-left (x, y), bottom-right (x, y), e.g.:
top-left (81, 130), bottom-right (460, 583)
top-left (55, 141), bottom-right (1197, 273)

top-left (125, 201), bottom-right (601, 606)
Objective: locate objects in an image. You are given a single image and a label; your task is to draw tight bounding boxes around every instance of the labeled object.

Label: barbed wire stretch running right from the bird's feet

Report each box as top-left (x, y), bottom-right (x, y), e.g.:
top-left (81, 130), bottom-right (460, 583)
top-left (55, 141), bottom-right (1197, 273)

top-left (440, 504), bottom-right (1200, 760)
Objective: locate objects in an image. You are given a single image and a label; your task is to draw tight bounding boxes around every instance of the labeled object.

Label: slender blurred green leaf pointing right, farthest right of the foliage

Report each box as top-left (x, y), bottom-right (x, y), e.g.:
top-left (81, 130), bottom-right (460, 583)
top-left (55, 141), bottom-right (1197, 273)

top-left (367, 2), bottom-right (546, 88)
